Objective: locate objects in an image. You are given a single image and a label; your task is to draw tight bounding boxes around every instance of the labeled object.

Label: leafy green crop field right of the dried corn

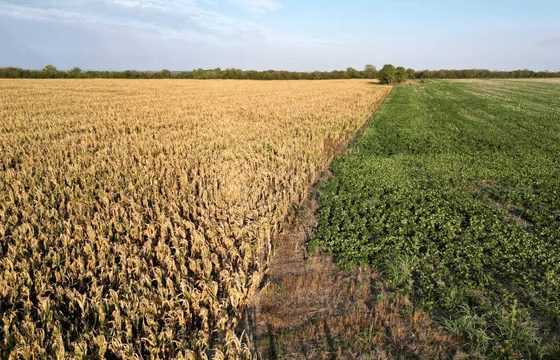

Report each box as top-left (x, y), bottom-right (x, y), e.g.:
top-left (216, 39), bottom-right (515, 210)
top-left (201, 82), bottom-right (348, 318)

top-left (312, 80), bottom-right (560, 358)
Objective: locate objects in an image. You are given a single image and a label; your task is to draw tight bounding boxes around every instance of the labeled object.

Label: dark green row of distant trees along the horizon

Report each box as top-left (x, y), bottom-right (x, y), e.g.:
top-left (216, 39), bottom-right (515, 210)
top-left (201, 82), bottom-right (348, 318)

top-left (0, 64), bottom-right (560, 84)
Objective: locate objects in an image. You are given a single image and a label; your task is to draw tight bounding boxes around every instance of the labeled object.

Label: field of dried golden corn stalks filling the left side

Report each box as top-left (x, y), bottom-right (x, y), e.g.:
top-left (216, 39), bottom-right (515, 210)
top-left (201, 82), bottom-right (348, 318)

top-left (0, 80), bottom-right (390, 358)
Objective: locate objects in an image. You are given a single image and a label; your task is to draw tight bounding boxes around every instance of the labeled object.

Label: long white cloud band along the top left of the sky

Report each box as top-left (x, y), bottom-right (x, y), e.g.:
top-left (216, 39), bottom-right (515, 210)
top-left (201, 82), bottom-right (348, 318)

top-left (0, 0), bottom-right (264, 42)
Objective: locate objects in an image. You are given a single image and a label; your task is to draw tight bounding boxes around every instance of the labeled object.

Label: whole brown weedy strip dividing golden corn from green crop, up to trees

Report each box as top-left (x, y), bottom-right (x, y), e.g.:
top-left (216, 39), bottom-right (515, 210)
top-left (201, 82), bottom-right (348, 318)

top-left (240, 87), bottom-right (457, 359)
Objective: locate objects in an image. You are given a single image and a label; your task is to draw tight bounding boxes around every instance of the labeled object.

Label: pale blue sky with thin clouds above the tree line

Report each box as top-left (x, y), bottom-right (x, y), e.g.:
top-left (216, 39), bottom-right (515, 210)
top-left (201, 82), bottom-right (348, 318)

top-left (0, 0), bottom-right (560, 71)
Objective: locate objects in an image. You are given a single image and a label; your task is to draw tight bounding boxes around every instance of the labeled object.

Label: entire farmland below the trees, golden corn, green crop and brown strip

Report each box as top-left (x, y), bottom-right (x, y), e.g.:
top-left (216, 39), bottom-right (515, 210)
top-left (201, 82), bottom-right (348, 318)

top-left (0, 79), bottom-right (560, 359)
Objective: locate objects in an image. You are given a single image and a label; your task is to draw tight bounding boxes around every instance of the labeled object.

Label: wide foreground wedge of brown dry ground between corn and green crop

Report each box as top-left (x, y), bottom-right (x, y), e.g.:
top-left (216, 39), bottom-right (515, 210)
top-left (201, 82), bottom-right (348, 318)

top-left (244, 88), bottom-right (461, 359)
